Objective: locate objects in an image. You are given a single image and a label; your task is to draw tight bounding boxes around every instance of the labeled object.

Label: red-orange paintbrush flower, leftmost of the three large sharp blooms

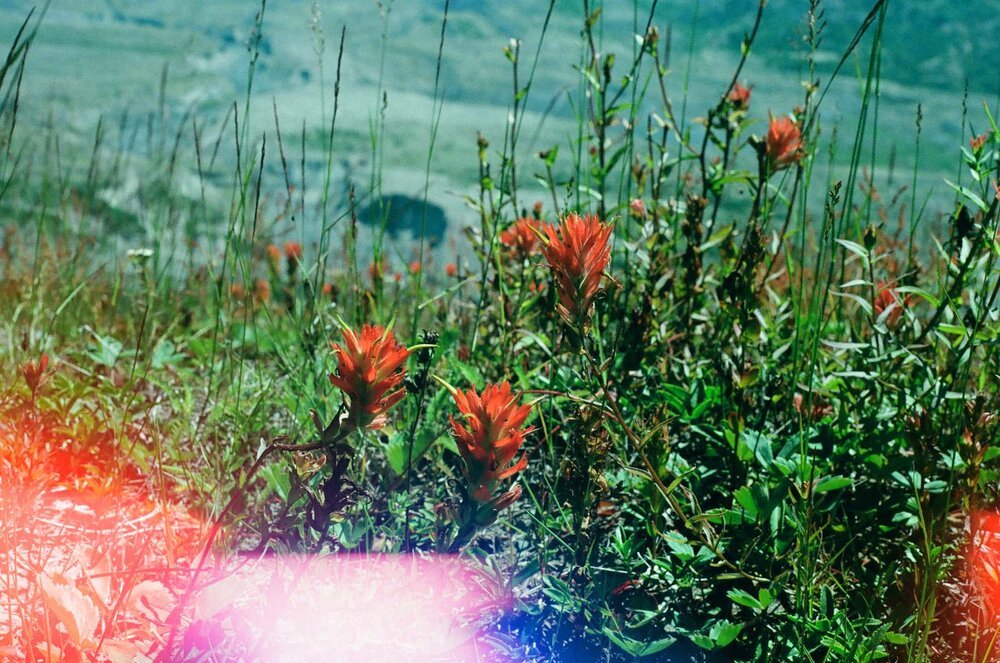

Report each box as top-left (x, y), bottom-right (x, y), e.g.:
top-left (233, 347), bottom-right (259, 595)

top-left (330, 325), bottom-right (410, 428)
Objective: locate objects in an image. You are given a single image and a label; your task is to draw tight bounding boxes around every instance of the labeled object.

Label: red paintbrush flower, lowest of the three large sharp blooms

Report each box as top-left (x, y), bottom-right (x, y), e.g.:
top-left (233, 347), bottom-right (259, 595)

top-left (450, 382), bottom-right (533, 510)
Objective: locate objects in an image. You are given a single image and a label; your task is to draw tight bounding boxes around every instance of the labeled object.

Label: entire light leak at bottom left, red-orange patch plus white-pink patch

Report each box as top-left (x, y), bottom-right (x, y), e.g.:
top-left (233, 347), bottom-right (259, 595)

top-left (0, 413), bottom-right (513, 663)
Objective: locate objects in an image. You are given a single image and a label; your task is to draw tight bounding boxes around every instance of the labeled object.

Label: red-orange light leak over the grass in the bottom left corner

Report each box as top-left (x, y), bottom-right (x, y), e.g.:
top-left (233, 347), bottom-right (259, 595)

top-left (0, 410), bottom-right (207, 663)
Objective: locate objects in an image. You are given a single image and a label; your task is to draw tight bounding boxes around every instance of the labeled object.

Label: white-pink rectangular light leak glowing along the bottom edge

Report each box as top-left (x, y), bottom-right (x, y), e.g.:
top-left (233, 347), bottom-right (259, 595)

top-left (194, 555), bottom-right (510, 663)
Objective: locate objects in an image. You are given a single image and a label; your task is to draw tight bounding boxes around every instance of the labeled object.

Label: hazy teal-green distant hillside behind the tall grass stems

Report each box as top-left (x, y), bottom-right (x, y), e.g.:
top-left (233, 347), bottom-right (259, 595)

top-left (0, 0), bottom-right (1000, 260)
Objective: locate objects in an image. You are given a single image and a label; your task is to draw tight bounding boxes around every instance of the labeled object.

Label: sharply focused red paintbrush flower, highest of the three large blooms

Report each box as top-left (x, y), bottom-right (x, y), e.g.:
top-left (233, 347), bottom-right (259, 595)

top-left (542, 214), bottom-right (614, 325)
